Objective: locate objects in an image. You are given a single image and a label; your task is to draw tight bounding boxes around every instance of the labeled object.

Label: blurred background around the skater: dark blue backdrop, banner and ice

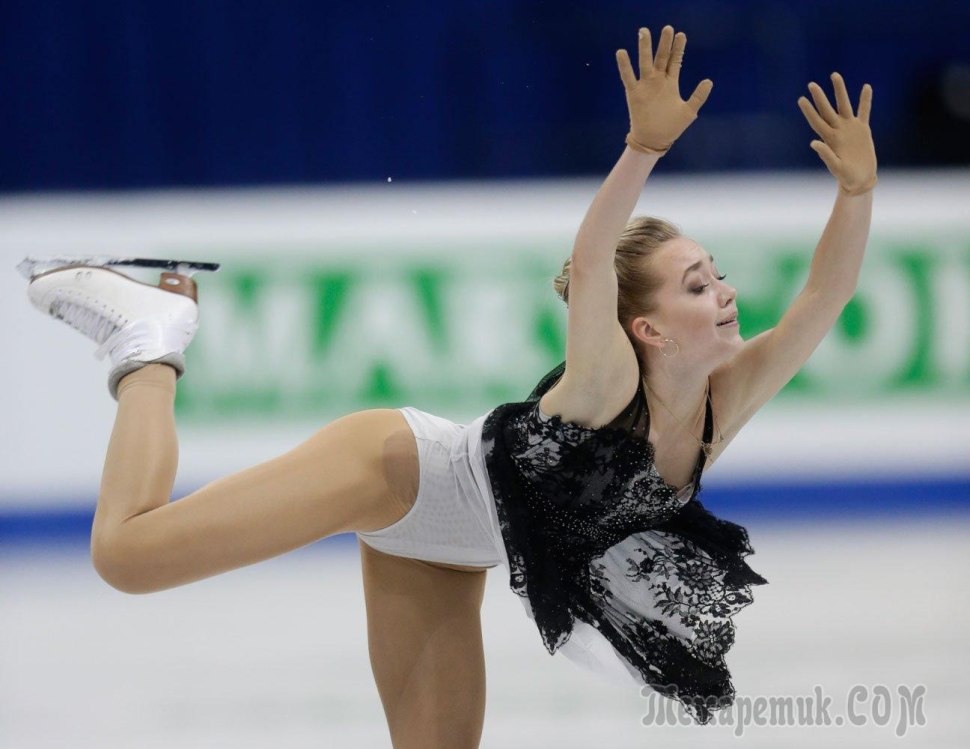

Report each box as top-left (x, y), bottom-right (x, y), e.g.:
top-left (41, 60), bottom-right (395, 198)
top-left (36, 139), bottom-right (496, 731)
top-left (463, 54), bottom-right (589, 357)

top-left (0, 0), bottom-right (970, 747)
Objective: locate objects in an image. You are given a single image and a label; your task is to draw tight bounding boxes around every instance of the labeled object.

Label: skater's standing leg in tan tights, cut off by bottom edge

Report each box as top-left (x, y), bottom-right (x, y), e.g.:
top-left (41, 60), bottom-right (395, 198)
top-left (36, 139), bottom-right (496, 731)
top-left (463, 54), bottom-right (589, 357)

top-left (359, 542), bottom-right (485, 749)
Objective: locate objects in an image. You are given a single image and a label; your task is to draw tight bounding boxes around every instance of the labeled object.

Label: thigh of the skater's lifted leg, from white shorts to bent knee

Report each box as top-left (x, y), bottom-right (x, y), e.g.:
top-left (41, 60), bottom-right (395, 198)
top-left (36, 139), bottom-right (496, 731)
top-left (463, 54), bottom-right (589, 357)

top-left (99, 409), bottom-right (419, 591)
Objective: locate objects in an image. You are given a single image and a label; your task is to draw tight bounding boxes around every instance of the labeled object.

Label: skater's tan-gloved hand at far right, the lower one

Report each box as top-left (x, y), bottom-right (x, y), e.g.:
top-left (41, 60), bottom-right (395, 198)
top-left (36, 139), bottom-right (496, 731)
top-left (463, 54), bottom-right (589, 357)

top-left (798, 73), bottom-right (877, 195)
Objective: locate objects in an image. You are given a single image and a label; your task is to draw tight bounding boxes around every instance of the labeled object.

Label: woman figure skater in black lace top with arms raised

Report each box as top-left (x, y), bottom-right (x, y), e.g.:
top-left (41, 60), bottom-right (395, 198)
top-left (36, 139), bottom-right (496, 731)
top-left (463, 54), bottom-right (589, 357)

top-left (19, 26), bottom-right (876, 748)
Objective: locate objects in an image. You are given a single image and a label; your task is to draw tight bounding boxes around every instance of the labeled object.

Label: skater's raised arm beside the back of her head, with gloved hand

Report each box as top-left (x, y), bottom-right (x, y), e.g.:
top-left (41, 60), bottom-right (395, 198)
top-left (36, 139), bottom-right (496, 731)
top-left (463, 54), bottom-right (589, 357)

top-left (563, 26), bottom-right (714, 392)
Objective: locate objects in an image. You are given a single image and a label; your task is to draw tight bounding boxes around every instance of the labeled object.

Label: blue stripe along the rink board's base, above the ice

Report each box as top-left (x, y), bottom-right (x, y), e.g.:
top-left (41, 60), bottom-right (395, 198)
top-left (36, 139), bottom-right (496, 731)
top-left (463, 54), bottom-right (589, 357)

top-left (0, 475), bottom-right (970, 545)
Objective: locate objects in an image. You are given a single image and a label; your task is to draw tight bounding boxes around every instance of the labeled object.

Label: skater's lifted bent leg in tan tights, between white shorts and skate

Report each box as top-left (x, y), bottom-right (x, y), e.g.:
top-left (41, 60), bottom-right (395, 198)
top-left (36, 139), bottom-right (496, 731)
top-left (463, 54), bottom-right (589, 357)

top-left (91, 364), bottom-right (418, 593)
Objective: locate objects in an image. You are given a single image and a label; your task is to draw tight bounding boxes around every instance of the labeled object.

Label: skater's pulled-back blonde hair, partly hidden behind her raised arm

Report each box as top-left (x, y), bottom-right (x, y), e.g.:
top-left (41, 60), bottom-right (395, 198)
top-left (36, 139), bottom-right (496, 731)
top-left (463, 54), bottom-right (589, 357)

top-left (552, 216), bottom-right (682, 358)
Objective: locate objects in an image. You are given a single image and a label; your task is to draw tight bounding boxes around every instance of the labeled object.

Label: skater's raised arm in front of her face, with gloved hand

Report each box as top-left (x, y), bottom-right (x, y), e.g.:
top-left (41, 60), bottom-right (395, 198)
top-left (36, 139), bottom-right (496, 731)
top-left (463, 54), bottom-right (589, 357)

top-left (717, 73), bottom-right (877, 434)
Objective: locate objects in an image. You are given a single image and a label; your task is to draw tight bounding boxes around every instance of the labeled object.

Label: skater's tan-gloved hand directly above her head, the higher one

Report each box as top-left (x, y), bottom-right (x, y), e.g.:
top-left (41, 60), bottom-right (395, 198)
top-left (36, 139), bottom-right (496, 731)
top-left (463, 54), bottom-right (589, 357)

top-left (616, 26), bottom-right (714, 154)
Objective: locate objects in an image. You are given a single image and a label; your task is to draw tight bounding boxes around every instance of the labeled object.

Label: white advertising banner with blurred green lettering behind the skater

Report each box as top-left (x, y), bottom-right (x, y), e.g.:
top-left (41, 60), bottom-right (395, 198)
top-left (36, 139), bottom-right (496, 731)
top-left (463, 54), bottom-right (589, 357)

top-left (0, 173), bottom-right (970, 506)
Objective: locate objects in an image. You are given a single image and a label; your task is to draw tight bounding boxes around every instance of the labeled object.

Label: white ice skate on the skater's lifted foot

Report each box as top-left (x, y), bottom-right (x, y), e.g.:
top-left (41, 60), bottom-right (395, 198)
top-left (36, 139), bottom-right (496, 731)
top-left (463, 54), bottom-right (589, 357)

top-left (17, 256), bottom-right (219, 400)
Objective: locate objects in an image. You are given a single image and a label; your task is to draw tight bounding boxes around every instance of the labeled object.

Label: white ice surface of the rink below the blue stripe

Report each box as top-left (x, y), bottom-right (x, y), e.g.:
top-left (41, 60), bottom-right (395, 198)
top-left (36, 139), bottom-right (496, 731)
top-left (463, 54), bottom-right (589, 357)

top-left (0, 514), bottom-right (970, 749)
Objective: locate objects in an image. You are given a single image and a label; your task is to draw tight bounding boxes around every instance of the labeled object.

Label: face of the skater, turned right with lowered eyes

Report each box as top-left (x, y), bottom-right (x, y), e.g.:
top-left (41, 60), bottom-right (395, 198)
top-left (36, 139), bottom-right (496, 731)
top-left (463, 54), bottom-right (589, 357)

top-left (641, 237), bottom-right (743, 366)
